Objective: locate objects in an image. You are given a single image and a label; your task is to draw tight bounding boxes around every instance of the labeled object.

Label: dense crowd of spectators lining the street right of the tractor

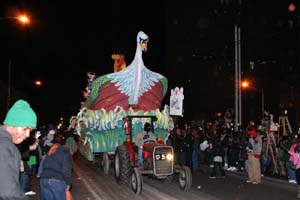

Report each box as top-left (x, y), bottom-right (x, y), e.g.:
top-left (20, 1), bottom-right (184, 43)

top-left (167, 109), bottom-right (300, 195)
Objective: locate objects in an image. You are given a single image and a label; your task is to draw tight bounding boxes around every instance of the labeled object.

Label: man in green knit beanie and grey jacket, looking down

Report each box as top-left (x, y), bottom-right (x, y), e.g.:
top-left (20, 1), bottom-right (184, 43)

top-left (0, 100), bottom-right (37, 200)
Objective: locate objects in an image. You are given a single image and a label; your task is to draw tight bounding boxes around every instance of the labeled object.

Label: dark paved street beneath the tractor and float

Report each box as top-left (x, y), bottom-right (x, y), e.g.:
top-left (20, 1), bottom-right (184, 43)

top-left (30, 156), bottom-right (297, 200)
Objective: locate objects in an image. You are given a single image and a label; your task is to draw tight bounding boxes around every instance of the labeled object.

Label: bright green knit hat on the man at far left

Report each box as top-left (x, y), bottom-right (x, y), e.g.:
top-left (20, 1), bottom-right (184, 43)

top-left (3, 100), bottom-right (37, 128)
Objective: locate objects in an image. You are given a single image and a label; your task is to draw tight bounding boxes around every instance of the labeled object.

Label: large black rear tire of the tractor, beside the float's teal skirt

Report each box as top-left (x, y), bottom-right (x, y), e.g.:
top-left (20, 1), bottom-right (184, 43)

top-left (115, 145), bottom-right (132, 184)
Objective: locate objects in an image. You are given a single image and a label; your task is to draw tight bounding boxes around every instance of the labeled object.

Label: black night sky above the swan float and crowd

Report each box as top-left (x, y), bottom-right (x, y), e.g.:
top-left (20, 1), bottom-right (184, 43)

top-left (0, 0), bottom-right (300, 127)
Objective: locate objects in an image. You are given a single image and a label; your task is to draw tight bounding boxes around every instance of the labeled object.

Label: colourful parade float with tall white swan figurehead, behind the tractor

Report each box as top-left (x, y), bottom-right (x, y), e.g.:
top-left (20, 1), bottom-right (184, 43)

top-left (76, 31), bottom-right (173, 173)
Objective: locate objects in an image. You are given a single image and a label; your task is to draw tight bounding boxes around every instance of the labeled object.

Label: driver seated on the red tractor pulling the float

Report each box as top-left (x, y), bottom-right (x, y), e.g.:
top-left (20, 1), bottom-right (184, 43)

top-left (135, 122), bottom-right (156, 167)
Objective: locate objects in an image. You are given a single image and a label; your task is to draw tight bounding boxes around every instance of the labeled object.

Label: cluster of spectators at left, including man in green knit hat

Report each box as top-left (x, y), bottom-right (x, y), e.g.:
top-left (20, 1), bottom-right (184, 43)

top-left (0, 100), bottom-right (77, 200)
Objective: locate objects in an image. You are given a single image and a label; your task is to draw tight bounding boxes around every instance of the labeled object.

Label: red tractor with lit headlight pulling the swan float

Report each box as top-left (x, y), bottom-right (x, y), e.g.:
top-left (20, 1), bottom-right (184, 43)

top-left (114, 116), bottom-right (192, 194)
